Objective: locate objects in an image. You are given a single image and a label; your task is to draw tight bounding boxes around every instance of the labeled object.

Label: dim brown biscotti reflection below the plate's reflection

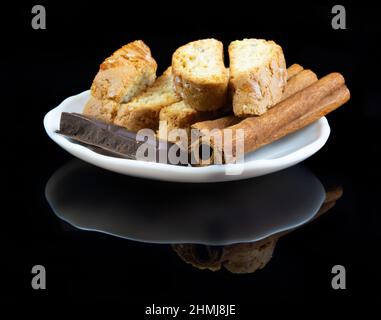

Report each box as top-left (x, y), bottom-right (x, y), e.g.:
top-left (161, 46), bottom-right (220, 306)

top-left (172, 237), bottom-right (277, 273)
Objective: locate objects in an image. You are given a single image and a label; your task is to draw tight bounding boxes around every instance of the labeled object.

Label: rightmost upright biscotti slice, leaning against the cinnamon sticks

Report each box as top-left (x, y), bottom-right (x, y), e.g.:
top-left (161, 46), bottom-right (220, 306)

top-left (229, 39), bottom-right (287, 116)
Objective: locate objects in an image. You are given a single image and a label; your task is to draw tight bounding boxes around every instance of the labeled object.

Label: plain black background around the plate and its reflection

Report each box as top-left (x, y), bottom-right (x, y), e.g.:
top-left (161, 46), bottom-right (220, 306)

top-left (1, 1), bottom-right (381, 314)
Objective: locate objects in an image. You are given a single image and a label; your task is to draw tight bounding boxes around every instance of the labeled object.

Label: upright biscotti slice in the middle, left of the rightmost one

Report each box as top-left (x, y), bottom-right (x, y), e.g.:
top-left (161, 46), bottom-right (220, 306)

top-left (172, 39), bottom-right (229, 111)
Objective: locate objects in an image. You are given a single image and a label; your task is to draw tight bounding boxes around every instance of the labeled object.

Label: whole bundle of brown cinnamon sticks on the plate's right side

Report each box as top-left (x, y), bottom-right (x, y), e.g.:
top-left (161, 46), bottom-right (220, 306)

top-left (190, 64), bottom-right (350, 165)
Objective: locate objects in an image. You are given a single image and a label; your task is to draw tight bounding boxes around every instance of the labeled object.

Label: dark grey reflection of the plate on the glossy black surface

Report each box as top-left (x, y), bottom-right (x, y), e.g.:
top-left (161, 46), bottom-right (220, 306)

top-left (45, 160), bottom-right (325, 245)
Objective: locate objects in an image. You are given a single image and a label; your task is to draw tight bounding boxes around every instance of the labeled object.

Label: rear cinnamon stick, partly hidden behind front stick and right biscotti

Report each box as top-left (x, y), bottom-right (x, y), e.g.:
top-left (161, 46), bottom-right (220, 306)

top-left (191, 64), bottom-right (318, 132)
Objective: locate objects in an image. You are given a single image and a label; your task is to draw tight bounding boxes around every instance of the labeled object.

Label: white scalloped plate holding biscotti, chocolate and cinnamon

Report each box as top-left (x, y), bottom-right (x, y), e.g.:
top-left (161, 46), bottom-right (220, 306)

top-left (44, 91), bottom-right (330, 182)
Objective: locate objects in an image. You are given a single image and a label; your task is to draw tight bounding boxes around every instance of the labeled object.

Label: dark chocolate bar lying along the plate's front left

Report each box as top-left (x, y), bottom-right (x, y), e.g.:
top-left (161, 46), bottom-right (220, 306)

top-left (57, 112), bottom-right (184, 165)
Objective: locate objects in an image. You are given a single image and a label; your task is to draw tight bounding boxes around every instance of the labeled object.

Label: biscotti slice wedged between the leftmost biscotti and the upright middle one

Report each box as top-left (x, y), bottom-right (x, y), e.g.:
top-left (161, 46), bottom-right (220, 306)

top-left (114, 67), bottom-right (181, 132)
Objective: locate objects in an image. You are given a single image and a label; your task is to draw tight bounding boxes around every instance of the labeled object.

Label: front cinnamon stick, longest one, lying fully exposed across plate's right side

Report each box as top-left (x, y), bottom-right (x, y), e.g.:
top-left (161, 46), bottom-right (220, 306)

top-left (196, 73), bottom-right (350, 164)
